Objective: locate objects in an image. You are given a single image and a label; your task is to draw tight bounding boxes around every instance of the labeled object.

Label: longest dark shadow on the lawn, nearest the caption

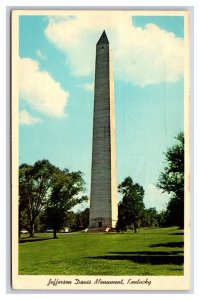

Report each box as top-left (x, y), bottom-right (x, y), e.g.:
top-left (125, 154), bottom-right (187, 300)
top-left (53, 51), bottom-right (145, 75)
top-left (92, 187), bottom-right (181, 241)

top-left (86, 251), bottom-right (184, 265)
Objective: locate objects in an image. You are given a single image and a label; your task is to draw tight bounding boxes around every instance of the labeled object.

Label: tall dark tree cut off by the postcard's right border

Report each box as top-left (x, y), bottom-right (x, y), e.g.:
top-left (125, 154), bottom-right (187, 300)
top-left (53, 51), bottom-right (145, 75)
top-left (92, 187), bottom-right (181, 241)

top-left (157, 132), bottom-right (184, 228)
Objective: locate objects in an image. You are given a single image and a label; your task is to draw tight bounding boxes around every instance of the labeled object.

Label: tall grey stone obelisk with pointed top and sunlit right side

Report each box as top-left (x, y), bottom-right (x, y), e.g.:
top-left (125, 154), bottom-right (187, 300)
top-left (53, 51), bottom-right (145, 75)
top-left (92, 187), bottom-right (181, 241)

top-left (89, 31), bottom-right (118, 228)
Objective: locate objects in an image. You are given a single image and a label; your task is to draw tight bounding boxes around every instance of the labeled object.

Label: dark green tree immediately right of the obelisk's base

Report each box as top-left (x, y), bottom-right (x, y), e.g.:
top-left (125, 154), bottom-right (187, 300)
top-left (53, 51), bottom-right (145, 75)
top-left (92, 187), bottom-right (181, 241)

top-left (117, 177), bottom-right (145, 233)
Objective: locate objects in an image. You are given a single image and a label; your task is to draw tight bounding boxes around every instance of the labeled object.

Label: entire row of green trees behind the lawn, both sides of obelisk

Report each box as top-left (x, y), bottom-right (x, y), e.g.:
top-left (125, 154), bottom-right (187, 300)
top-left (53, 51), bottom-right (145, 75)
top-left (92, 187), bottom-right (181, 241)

top-left (19, 132), bottom-right (184, 238)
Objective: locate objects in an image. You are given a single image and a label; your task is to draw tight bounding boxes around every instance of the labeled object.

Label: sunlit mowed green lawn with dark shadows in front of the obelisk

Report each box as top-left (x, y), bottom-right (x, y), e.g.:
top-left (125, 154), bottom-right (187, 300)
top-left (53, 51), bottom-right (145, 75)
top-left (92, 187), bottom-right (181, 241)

top-left (19, 227), bottom-right (184, 275)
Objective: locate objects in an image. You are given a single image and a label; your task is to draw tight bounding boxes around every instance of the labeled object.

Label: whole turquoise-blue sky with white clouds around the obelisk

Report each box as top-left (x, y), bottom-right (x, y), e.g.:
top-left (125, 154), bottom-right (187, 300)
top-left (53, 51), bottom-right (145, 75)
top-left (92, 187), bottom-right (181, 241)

top-left (19, 12), bottom-right (184, 210)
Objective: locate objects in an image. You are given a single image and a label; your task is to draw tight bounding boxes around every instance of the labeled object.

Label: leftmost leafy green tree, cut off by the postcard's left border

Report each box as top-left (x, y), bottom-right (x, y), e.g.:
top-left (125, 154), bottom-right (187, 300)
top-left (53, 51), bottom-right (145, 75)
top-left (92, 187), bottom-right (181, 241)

top-left (19, 160), bottom-right (55, 237)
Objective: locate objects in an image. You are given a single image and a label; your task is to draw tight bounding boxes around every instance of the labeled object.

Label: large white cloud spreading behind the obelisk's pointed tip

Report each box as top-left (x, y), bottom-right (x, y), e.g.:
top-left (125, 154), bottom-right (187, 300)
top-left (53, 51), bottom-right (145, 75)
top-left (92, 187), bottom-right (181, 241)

top-left (45, 11), bottom-right (184, 86)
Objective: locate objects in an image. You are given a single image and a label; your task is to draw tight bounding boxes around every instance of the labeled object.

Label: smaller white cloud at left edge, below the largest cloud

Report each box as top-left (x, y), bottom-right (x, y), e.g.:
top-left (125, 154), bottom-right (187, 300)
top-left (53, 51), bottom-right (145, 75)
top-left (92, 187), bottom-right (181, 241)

top-left (19, 58), bottom-right (69, 117)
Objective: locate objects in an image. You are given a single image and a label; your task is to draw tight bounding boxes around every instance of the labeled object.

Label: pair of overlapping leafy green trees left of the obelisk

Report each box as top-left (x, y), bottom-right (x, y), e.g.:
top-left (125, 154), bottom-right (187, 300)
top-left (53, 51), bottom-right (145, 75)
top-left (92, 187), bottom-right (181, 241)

top-left (19, 160), bottom-right (87, 236)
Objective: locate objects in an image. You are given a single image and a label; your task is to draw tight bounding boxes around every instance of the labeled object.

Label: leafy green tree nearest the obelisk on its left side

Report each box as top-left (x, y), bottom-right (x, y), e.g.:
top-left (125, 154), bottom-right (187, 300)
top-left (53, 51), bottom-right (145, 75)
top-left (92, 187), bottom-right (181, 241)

top-left (45, 169), bottom-right (87, 238)
